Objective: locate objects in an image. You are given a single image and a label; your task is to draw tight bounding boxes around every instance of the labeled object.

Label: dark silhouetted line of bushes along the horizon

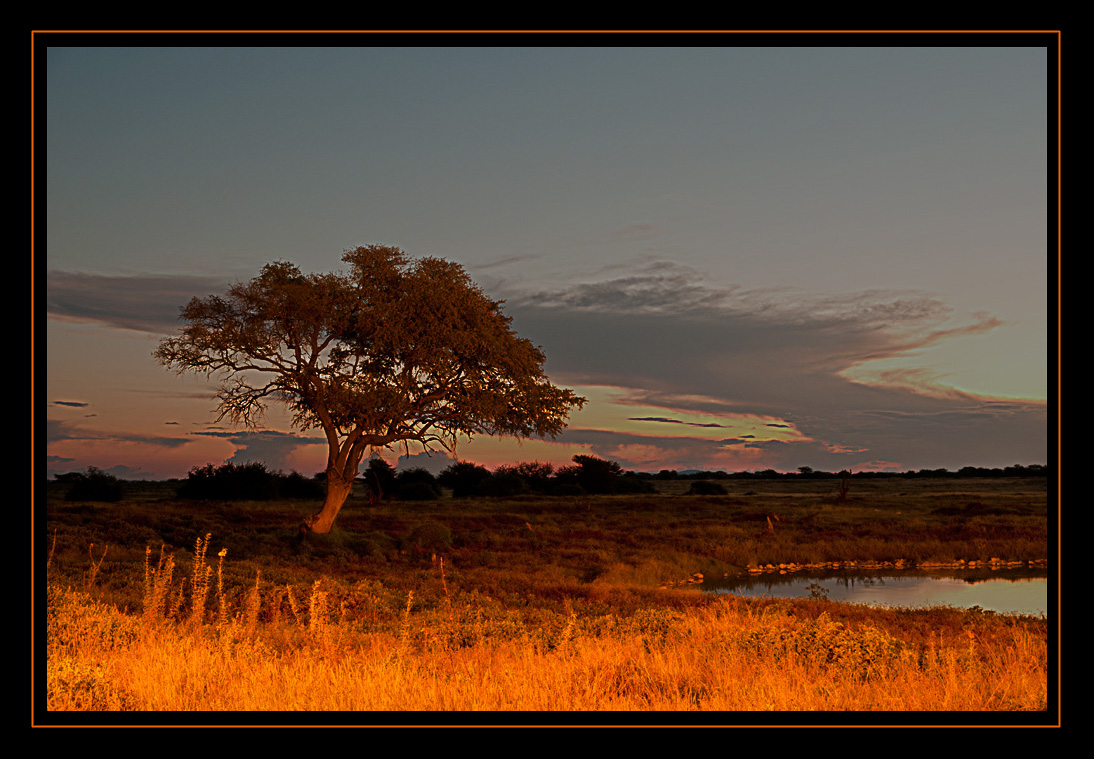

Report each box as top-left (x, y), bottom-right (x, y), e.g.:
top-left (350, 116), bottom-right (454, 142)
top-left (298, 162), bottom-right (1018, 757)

top-left (55, 455), bottom-right (1049, 502)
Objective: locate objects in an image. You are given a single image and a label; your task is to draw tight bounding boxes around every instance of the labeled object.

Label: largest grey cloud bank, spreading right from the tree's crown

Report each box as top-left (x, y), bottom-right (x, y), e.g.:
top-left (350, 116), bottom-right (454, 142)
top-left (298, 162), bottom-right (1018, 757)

top-left (505, 261), bottom-right (1048, 469)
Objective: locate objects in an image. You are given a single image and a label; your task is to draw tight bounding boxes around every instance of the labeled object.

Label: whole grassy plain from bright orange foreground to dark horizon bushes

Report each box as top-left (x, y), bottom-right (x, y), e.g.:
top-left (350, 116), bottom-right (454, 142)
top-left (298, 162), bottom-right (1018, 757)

top-left (38, 479), bottom-right (1055, 724)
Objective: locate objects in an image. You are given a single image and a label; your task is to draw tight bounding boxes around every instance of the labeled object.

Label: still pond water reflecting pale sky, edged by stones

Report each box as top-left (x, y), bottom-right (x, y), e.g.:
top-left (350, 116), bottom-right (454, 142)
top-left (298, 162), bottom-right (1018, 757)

top-left (702, 571), bottom-right (1048, 615)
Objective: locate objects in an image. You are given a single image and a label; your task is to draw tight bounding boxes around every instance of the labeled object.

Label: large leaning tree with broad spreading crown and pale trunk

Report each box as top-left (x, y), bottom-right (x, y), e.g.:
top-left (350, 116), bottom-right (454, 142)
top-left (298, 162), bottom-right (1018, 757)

top-left (154, 245), bottom-right (585, 533)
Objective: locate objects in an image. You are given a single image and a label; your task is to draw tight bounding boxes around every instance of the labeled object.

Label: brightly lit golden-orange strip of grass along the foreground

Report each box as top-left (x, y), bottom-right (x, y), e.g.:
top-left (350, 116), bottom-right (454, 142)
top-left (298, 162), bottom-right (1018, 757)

top-left (46, 564), bottom-right (1048, 722)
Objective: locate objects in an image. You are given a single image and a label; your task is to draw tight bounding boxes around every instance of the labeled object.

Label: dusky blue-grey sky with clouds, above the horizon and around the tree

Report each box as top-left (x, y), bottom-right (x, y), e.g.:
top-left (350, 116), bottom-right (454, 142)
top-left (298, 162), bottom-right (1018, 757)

top-left (35, 35), bottom-right (1057, 479)
